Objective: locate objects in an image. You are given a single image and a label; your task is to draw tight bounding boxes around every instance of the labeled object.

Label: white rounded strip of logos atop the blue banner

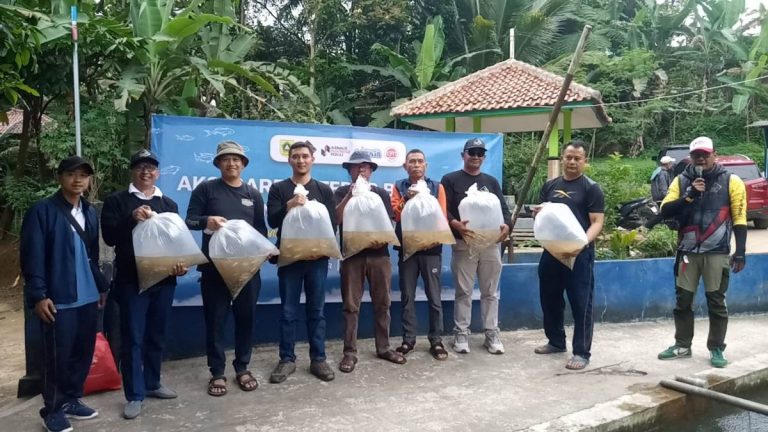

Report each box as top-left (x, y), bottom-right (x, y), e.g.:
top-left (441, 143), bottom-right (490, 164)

top-left (269, 135), bottom-right (405, 167)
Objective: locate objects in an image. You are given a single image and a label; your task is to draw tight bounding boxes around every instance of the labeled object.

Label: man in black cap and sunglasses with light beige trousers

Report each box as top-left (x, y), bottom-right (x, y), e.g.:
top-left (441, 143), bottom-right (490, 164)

top-left (440, 138), bottom-right (511, 354)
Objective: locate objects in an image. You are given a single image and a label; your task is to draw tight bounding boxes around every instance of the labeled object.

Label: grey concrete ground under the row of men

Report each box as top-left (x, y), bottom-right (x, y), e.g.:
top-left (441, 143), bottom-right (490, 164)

top-left (0, 315), bottom-right (768, 432)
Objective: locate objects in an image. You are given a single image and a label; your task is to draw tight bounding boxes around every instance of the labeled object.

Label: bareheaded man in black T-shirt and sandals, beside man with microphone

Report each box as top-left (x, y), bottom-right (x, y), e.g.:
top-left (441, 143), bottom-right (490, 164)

top-left (534, 140), bottom-right (605, 369)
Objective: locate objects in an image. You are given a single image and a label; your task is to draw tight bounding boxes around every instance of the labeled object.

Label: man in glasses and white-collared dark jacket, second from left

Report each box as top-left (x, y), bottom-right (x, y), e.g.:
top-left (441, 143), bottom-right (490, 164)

top-left (101, 150), bottom-right (187, 419)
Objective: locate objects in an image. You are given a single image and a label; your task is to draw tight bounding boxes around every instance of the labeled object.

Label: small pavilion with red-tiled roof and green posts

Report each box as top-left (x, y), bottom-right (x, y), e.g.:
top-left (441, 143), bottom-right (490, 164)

top-left (392, 59), bottom-right (611, 178)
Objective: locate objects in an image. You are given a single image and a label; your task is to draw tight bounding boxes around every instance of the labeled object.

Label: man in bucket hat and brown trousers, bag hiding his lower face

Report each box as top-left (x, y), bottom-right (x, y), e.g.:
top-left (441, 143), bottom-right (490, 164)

top-left (334, 151), bottom-right (406, 373)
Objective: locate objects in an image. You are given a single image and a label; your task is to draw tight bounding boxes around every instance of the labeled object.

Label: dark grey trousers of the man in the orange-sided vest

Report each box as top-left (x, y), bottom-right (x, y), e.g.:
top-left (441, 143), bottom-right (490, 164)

top-left (398, 254), bottom-right (443, 345)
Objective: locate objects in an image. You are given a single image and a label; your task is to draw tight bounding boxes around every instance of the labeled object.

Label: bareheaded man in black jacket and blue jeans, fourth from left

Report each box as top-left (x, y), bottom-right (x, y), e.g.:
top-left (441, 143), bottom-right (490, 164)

top-left (267, 141), bottom-right (336, 384)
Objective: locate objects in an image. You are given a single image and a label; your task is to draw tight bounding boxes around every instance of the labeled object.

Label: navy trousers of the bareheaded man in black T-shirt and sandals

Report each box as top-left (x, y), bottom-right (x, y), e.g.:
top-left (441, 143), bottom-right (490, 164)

top-left (539, 247), bottom-right (595, 359)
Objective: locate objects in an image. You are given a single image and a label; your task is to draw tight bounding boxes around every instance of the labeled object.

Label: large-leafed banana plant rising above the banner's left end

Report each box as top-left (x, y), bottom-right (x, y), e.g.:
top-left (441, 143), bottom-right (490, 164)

top-left (113, 0), bottom-right (277, 147)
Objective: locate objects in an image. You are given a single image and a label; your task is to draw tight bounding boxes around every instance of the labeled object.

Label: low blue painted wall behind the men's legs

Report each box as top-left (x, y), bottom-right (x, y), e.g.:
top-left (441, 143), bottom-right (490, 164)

top-left (167, 254), bottom-right (768, 360)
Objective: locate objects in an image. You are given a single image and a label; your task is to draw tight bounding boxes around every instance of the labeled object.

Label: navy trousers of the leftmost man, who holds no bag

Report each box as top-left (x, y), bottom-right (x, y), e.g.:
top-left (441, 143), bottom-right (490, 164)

top-left (40, 302), bottom-right (99, 418)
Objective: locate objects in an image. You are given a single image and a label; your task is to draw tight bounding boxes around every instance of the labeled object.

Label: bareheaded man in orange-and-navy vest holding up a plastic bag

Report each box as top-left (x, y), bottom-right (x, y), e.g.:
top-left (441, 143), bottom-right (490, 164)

top-left (392, 149), bottom-right (455, 360)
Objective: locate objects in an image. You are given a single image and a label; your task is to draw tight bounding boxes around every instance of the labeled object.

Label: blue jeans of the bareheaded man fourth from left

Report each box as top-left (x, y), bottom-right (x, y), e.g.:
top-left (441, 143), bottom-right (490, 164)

top-left (277, 258), bottom-right (328, 362)
